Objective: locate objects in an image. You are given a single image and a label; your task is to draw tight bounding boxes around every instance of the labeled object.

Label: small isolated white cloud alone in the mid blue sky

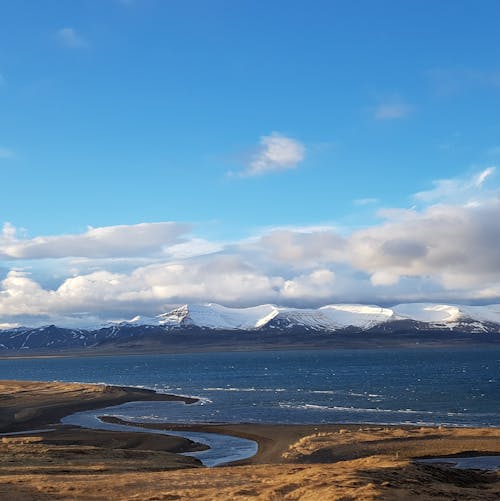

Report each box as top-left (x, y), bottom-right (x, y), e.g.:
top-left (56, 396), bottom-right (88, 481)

top-left (242, 132), bottom-right (306, 176)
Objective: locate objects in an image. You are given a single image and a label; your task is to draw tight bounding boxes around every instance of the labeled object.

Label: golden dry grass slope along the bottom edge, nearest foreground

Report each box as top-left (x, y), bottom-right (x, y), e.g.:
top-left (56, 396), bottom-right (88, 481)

top-left (0, 456), bottom-right (500, 501)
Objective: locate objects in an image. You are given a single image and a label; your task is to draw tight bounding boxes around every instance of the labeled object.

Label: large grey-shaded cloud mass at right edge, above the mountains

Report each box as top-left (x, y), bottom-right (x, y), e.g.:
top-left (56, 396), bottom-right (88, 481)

top-left (349, 200), bottom-right (500, 289)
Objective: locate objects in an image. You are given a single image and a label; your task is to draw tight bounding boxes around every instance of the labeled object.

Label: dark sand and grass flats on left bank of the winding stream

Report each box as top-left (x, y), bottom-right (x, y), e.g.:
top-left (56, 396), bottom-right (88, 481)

top-left (0, 381), bottom-right (205, 474)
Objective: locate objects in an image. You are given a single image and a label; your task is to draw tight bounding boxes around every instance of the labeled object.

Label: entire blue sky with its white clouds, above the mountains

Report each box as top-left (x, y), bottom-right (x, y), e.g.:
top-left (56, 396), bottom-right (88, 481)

top-left (0, 0), bottom-right (500, 328)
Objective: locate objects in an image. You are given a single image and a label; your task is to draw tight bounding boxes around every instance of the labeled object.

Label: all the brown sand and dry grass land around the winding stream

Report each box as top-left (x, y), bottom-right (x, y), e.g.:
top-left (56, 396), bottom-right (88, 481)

top-left (0, 381), bottom-right (500, 501)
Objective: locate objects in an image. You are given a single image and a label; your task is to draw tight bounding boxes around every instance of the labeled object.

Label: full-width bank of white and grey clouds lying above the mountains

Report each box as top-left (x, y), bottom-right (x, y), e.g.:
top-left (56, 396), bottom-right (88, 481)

top-left (0, 167), bottom-right (500, 325)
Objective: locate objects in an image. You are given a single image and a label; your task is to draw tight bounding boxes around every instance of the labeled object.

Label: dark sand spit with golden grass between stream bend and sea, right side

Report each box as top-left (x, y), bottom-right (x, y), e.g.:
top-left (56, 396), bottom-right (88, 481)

top-left (99, 416), bottom-right (500, 466)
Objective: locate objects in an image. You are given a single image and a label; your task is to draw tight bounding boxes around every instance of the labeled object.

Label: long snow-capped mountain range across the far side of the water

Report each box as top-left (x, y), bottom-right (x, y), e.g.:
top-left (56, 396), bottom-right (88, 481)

top-left (0, 303), bottom-right (500, 353)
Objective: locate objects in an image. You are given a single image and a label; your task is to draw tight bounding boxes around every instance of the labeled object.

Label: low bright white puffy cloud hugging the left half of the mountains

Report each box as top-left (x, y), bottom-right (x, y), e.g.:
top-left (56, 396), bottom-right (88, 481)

top-left (0, 256), bottom-right (283, 323)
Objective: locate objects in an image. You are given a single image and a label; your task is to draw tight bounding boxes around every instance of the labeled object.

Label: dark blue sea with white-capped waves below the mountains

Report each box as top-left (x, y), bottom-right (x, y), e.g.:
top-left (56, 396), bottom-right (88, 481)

top-left (0, 347), bottom-right (500, 426)
